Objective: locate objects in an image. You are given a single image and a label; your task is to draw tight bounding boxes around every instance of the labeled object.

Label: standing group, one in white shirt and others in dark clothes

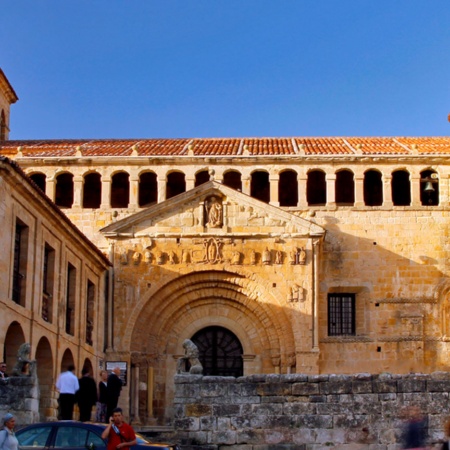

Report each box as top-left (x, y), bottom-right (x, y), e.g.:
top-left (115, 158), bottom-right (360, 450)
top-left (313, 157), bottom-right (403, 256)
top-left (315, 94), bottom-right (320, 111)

top-left (56, 365), bottom-right (122, 423)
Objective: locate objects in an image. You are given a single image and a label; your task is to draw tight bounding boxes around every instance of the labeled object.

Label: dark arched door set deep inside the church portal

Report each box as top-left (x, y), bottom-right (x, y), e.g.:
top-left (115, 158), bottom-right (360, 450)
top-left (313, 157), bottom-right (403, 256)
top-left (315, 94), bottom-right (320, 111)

top-left (192, 326), bottom-right (244, 378)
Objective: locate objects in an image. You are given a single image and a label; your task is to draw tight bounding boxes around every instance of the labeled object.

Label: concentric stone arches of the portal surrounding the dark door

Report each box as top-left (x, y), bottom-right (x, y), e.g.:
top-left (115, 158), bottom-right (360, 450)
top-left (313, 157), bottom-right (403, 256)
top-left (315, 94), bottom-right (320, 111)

top-left (127, 269), bottom-right (299, 423)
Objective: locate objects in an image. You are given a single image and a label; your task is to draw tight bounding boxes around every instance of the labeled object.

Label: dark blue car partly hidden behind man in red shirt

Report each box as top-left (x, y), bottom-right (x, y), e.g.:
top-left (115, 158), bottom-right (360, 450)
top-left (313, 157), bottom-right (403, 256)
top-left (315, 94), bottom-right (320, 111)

top-left (16, 420), bottom-right (179, 450)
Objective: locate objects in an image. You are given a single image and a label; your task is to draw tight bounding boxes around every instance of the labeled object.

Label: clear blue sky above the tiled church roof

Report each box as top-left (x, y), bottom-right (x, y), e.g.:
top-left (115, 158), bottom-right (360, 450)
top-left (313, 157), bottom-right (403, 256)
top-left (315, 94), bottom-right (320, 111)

top-left (0, 0), bottom-right (450, 139)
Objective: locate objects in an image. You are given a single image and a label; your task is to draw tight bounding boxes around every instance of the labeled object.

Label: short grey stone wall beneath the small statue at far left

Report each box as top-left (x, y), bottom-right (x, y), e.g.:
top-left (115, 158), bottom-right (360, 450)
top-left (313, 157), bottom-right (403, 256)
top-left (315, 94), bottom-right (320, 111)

top-left (0, 377), bottom-right (39, 427)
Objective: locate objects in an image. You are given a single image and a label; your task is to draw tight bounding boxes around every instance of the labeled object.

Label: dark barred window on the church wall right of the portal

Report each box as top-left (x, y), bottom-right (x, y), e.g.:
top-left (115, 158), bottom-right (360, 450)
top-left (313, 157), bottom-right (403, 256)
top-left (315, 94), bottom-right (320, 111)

top-left (328, 294), bottom-right (355, 336)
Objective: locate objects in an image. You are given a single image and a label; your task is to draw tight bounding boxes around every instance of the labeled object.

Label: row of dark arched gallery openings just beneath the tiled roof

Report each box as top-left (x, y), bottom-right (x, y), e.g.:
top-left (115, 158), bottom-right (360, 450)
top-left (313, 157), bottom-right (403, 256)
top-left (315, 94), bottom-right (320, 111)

top-left (30, 169), bottom-right (439, 209)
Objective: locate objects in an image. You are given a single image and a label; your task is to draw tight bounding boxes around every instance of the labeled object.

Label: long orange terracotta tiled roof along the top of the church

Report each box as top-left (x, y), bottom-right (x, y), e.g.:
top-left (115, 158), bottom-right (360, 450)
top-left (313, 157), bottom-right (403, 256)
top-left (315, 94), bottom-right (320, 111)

top-left (0, 137), bottom-right (450, 158)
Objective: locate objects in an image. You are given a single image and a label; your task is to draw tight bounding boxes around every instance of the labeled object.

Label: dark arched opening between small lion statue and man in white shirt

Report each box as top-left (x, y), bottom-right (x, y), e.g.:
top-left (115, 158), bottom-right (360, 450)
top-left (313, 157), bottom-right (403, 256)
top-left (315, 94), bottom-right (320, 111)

top-left (36, 337), bottom-right (56, 421)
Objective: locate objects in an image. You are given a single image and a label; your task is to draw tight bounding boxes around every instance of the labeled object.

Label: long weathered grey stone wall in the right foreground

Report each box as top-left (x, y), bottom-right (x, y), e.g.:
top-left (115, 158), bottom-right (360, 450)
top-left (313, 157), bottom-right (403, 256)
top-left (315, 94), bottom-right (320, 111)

top-left (174, 372), bottom-right (450, 450)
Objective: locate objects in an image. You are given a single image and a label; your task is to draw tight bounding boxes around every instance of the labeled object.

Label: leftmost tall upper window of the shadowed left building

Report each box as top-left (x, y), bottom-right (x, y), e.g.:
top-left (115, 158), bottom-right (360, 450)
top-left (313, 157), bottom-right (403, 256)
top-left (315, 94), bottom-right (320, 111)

top-left (12, 219), bottom-right (28, 306)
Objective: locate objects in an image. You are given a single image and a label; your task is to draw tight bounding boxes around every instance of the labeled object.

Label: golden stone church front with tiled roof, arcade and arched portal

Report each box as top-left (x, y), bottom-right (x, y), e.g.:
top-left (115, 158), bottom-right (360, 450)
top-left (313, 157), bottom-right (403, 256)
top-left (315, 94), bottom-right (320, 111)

top-left (0, 70), bottom-right (450, 423)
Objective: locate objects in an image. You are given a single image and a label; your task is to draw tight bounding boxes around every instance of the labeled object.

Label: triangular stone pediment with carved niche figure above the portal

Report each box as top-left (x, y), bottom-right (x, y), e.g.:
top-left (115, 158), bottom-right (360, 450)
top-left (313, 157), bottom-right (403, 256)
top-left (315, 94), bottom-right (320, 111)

top-left (100, 181), bottom-right (325, 238)
